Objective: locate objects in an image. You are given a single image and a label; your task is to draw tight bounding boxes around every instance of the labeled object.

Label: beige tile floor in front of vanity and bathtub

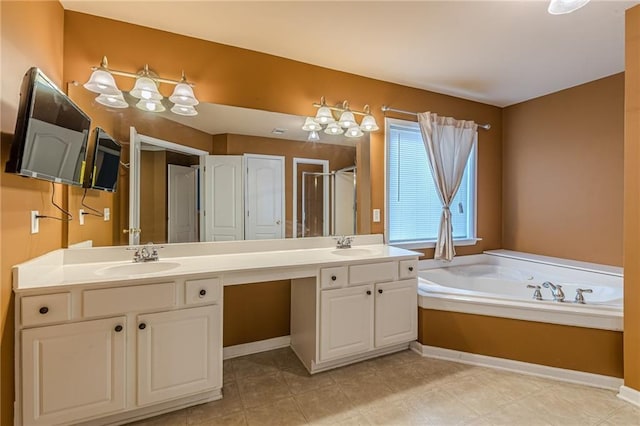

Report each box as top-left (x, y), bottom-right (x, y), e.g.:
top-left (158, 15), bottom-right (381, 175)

top-left (127, 348), bottom-right (640, 426)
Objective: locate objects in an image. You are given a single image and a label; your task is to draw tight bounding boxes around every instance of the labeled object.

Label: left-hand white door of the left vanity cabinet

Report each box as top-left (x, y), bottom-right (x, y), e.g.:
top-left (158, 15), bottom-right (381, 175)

top-left (22, 317), bottom-right (126, 425)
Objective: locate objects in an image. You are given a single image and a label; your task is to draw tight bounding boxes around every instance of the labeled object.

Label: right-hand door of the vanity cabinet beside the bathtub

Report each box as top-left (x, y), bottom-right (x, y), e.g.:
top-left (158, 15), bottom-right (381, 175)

top-left (375, 279), bottom-right (418, 347)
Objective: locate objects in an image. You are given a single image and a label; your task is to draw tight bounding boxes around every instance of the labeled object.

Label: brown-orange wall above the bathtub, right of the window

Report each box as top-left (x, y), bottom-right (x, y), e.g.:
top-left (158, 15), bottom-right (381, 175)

top-left (502, 74), bottom-right (624, 266)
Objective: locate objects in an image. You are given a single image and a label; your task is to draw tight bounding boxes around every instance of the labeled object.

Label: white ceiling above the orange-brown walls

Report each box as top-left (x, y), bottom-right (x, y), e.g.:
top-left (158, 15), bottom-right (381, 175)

top-left (61, 0), bottom-right (640, 106)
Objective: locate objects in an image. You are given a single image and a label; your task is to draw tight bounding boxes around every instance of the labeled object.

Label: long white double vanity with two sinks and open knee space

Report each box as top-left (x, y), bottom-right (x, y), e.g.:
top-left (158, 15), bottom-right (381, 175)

top-left (13, 235), bottom-right (418, 425)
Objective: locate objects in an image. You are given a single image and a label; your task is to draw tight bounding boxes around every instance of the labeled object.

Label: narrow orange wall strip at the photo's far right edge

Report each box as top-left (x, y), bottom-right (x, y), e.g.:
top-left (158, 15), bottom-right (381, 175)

top-left (624, 6), bottom-right (640, 391)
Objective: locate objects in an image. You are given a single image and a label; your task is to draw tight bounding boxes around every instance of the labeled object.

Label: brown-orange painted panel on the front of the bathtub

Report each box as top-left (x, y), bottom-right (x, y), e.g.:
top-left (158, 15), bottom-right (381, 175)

top-left (418, 308), bottom-right (623, 377)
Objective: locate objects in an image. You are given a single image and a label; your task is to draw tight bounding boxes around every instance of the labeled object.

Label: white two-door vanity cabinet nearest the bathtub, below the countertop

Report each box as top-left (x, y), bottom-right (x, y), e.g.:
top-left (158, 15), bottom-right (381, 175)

top-left (291, 258), bottom-right (418, 373)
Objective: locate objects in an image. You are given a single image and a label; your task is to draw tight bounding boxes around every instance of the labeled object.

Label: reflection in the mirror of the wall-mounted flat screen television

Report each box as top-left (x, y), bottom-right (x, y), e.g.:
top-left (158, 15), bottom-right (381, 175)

top-left (85, 127), bottom-right (122, 192)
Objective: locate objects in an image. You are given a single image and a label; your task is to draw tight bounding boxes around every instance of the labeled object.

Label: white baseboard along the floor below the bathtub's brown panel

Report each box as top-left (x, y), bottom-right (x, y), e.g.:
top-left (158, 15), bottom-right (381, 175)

top-left (411, 342), bottom-right (624, 392)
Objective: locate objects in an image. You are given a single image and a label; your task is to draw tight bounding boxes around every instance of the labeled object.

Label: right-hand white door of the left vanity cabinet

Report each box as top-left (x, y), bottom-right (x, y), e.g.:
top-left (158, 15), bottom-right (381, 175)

top-left (137, 305), bottom-right (222, 405)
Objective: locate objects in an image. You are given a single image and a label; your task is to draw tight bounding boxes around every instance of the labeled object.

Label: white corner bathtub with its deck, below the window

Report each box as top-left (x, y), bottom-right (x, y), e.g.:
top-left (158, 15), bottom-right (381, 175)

top-left (418, 250), bottom-right (623, 331)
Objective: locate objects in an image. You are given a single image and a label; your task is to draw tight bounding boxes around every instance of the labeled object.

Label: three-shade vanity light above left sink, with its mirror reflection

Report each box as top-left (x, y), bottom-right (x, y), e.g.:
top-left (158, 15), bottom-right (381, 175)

top-left (84, 56), bottom-right (199, 116)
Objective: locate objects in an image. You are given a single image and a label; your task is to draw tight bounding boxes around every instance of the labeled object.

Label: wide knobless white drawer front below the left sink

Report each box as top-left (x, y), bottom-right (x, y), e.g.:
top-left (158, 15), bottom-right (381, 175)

top-left (82, 282), bottom-right (176, 317)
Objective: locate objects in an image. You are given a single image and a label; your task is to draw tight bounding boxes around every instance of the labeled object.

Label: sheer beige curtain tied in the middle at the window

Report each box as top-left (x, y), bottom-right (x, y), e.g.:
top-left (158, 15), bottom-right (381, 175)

top-left (418, 112), bottom-right (478, 261)
